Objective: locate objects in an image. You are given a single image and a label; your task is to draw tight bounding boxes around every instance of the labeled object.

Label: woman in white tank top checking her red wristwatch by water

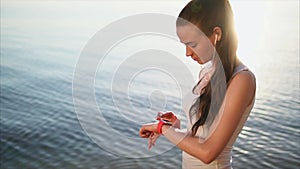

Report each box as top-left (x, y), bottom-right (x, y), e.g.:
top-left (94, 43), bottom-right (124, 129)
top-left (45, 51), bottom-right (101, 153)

top-left (140, 0), bottom-right (256, 169)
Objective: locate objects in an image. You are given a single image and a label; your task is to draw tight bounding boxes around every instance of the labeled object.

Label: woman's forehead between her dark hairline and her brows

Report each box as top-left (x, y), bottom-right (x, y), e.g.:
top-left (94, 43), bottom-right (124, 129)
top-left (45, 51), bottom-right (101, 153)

top-left (176, 24), bottom-right (205, 43)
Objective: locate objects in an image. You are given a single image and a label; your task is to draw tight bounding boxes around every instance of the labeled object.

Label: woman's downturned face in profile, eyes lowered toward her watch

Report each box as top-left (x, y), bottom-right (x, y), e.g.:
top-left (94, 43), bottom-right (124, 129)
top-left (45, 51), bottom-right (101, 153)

top-left (176, 23), bottom-right (214, 64)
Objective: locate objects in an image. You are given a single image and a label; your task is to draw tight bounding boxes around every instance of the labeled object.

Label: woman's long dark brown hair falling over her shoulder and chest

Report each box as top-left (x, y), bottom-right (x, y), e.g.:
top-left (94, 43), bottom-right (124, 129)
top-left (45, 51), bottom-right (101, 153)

top-left (176, 0), bottom-right (237, 135)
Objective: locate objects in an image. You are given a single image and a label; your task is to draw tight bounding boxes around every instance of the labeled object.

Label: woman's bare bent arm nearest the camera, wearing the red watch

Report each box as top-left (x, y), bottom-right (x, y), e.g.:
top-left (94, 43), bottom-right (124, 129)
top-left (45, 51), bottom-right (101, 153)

top-left (140, 71), bottom-right (255, 163)
